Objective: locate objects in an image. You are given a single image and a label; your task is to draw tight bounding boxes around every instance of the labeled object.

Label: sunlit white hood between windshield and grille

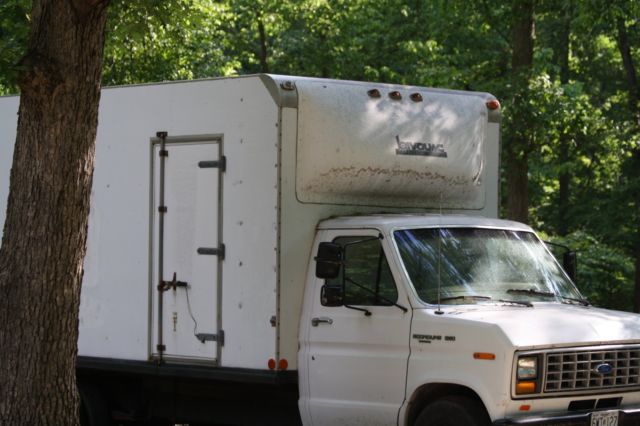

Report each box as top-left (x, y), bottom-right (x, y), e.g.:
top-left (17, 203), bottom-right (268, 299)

top-left (447, 303), bottom-right (640, 349)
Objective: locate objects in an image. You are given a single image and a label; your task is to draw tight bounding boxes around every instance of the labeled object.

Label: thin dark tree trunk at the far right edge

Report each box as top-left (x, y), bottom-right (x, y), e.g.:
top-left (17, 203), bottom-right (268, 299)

top-left (616, 16), bottom-right (640, 312)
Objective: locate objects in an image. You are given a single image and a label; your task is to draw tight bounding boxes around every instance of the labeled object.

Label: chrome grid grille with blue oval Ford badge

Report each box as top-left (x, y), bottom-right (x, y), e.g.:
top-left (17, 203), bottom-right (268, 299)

top-left (544, 346), bottom-right (640, 392)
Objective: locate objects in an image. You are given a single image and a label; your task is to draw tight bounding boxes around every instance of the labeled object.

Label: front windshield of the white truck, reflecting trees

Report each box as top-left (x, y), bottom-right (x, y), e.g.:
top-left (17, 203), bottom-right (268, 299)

top-left (394, 228), bottom-right (584, 304)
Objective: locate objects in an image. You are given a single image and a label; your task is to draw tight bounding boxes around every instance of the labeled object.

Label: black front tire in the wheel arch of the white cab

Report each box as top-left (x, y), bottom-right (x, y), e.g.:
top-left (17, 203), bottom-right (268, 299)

top-left (414, 396), bottom-right (490, 426)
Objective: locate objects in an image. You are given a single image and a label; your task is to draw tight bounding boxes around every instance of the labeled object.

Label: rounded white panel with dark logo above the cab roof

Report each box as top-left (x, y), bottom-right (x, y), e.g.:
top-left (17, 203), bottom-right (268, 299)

top-left (296, 80), bottom-right (488, 210)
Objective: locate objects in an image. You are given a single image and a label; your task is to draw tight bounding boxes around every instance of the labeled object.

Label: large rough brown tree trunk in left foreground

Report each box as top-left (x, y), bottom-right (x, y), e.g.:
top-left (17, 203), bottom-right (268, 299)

top-left (0, 0), bottom-right (108, 425)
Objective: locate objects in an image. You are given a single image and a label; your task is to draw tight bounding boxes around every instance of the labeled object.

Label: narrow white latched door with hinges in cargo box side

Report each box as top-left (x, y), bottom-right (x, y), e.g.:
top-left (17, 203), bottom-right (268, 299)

top-left (150, 136), bottom-right (224, 362)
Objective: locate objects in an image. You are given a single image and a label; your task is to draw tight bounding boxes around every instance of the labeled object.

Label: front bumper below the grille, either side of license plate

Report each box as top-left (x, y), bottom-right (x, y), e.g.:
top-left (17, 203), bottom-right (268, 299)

top-left (493, 408), bottom-right (640, 426)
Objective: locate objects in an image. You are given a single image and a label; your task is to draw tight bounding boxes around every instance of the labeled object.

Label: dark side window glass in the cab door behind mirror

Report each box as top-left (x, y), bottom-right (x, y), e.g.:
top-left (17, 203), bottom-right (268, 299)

top-left (327, 237), bottom-right (398, 306)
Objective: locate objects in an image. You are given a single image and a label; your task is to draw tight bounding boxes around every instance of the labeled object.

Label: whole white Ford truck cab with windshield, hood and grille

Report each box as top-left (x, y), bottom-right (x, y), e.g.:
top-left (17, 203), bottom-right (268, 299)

top-left (298, 215), bottom-right (640, 426)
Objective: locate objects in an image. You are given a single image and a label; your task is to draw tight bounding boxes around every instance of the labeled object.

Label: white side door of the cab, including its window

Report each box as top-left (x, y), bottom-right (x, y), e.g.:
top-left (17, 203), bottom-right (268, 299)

top-left (301, 230), bottom-right (411, 426)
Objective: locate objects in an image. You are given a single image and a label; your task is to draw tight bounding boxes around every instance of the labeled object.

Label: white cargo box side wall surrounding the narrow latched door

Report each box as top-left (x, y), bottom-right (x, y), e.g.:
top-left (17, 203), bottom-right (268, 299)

top-left (74, 78), bottom-right (277, 368)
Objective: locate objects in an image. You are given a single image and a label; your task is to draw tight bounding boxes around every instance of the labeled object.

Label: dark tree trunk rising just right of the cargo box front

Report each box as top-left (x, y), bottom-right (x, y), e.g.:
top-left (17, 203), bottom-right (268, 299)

top-left (505, 0), bottom-right (534, 222)
